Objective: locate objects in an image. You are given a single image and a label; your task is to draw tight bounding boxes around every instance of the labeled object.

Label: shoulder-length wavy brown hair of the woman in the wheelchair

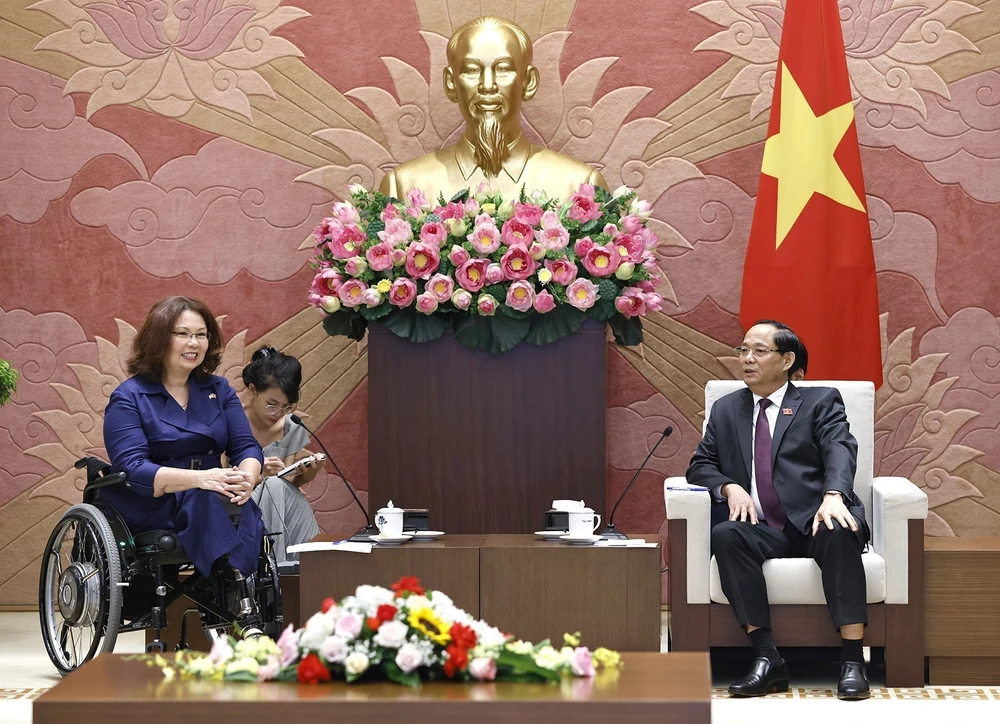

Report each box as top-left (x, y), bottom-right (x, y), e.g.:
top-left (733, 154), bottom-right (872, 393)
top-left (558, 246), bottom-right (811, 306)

top-left (126, 297), bottom-right (222, 382)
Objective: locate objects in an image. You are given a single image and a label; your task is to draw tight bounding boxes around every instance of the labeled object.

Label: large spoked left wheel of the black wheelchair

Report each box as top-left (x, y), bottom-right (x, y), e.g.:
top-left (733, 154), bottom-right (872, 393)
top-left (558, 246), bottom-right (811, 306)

top-left (38, 504), bottom-right (122, 676)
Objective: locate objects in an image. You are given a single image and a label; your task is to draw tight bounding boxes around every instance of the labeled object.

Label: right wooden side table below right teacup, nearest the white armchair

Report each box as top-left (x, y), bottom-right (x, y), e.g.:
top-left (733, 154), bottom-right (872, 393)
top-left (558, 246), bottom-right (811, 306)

top-left (479, 533), bottom-right (660, 651)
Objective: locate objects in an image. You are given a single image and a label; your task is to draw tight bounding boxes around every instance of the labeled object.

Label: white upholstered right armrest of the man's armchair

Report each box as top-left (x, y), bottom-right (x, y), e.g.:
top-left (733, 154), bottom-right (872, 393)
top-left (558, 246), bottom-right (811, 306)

top-left (872, 477), bottom-right (927, 604)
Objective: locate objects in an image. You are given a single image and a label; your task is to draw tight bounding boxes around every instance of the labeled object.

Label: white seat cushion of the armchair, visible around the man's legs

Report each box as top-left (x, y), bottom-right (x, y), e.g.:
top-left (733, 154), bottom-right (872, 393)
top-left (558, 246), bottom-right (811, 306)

top-left (709, 553), bottom-right (886, 605)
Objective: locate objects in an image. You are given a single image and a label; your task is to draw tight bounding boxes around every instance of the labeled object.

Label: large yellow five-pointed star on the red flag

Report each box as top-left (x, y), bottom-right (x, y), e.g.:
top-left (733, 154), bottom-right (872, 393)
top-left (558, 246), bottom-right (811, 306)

top-left (761, 63), bottom-right (865, 249)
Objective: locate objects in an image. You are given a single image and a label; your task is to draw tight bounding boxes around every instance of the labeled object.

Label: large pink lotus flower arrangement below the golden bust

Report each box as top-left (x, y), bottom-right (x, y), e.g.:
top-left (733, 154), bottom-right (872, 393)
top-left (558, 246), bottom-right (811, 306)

top-left (309, 184), bottom-right (663, 354)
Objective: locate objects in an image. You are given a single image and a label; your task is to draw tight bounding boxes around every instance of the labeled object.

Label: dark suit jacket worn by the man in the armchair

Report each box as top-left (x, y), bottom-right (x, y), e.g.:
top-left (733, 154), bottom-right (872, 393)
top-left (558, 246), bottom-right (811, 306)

top-left (687, 383), bottom-right (869, 540)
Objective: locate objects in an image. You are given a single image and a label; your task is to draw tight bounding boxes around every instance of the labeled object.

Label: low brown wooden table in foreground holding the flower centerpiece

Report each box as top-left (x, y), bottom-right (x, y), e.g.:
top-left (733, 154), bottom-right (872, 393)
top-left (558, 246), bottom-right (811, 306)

top-left (33, 653), bottom-right (712, 724)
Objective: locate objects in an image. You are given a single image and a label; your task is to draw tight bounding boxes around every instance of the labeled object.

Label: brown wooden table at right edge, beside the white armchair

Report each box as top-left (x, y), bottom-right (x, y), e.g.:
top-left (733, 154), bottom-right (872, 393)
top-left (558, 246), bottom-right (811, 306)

top-left (924, 537), bottom-right (1000, 686)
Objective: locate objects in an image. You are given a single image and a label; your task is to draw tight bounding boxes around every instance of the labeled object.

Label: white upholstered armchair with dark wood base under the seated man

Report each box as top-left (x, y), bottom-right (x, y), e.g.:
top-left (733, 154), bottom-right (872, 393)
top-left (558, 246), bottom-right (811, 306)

top-left (664, 380), bottom-right (927, 686)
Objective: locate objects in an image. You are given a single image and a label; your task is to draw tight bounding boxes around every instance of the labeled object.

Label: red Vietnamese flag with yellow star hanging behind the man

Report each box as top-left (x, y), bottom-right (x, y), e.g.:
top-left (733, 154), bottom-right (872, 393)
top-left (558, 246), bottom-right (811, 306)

top-left (740, 0), bottom-right (882, 387)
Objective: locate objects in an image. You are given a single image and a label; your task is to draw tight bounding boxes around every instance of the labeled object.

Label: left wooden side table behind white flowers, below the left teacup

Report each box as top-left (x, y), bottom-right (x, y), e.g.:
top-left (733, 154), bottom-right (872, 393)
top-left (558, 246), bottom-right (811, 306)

top-left (298, 535), bottom-right (486, 624)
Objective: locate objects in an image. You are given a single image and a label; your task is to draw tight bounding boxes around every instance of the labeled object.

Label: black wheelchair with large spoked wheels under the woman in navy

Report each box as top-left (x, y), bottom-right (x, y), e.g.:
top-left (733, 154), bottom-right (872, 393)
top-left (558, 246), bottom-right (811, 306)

top-left (38, 457), bottom-right (282, 676)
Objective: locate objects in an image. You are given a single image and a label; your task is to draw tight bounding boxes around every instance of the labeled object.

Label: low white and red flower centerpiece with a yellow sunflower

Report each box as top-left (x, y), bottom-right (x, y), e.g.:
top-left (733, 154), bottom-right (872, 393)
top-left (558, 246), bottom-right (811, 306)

top-left (141, 576), bottom-right (621, 686)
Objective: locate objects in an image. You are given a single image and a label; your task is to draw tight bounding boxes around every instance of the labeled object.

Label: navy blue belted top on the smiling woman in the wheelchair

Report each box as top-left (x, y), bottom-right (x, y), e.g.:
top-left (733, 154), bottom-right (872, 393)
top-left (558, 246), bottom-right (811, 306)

top-left (104, 375), bottom-right (264, 497)
